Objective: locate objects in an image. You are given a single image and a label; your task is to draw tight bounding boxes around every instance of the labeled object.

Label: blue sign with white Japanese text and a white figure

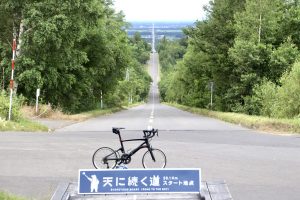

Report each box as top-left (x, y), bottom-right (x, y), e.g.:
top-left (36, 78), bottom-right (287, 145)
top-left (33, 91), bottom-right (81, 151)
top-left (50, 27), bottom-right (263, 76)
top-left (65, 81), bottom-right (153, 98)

top-left (78, 169), bottom-right (201, 194)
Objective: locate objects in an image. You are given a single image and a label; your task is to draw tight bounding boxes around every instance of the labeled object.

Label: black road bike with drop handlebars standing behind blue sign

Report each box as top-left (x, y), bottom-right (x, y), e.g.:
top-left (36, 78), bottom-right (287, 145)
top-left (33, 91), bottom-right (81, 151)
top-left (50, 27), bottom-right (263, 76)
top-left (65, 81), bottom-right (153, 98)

top-left (93, 128), bottom-right (167, 169)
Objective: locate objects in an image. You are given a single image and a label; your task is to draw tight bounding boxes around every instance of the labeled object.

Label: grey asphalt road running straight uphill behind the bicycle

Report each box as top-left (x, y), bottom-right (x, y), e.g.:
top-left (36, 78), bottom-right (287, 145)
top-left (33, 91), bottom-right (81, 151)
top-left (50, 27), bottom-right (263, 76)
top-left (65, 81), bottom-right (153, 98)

top-left (0, 53), bottom-right (300, 200)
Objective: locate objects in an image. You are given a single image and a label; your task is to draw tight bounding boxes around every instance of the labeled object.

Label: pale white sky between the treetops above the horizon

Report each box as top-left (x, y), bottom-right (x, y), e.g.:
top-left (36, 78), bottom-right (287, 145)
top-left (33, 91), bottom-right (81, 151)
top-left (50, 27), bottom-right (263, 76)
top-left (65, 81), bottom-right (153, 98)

top-left (114, 0), bottom-right (209, 22)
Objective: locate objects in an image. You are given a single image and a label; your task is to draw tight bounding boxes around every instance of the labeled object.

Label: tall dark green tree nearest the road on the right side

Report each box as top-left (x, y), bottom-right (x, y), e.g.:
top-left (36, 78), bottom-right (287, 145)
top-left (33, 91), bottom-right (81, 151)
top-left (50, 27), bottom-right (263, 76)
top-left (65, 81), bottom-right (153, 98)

top-left (161, 0), bottom-right (244, 110)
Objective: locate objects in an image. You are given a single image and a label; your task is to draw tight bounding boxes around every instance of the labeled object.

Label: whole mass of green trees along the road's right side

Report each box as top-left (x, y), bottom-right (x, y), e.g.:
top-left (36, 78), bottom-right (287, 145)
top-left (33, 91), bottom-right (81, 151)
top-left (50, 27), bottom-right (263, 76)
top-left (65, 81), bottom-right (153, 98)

top-left (161, 0), bottom-right (300, 117)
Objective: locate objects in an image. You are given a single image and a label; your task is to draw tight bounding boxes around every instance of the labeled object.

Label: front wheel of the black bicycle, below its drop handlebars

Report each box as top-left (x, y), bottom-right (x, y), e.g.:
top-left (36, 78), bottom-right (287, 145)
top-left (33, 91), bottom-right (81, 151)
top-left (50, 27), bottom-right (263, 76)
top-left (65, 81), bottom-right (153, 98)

top-left (142, 149), bottom-right (167, 168)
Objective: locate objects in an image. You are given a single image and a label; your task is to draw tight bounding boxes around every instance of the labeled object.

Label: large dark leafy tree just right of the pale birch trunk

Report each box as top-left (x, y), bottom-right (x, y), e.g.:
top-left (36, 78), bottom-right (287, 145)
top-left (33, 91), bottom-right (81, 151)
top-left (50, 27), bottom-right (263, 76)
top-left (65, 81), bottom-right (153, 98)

top-left (17, 0), bottom-right (109, 112)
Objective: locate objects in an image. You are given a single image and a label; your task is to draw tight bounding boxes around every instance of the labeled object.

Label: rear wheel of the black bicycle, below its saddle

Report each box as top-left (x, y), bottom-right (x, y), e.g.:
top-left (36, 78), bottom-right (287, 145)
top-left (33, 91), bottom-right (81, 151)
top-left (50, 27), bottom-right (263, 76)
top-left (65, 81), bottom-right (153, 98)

top-left (93, 147), bottom-right (118, 169)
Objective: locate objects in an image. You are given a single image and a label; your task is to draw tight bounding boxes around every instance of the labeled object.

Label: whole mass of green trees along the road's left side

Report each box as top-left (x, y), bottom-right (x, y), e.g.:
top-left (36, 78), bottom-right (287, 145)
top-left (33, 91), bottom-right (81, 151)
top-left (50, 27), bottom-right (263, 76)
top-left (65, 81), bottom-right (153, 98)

top-left (0, 0), bottom-right (150, 113)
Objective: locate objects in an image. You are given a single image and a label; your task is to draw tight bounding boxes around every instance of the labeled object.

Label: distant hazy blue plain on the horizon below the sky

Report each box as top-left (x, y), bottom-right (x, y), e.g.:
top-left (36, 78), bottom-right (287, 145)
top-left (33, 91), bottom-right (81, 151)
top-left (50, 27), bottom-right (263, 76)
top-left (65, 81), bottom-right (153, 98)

top-left (127, 22), bottom-right (194, 43)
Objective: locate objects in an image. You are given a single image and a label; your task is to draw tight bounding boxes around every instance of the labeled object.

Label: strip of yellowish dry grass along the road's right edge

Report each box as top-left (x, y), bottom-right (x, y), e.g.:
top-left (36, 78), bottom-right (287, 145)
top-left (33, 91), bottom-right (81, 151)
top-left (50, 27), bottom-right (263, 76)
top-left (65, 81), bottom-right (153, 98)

top-left (165, 103), bottom-right (300, 133)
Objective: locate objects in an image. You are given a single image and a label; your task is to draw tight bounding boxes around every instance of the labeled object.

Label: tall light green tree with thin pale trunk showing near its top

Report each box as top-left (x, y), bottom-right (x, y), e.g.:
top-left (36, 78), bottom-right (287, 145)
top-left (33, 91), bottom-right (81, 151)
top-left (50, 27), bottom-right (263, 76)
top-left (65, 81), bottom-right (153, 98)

top-left (228, 0), bottom-right (284, 114)
